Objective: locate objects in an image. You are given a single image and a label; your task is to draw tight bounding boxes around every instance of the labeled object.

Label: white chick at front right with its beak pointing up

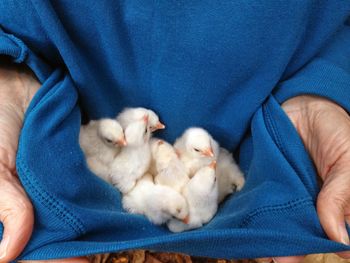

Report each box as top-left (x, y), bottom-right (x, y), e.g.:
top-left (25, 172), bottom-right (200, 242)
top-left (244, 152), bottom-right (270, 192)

top-left (167, 161), bottom-right (218, 232)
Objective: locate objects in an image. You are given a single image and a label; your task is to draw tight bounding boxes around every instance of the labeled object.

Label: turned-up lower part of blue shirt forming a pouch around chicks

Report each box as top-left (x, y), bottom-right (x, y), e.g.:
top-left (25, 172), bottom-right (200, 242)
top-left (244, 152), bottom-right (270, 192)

top-left (0, 26), bottom-right (350, 260)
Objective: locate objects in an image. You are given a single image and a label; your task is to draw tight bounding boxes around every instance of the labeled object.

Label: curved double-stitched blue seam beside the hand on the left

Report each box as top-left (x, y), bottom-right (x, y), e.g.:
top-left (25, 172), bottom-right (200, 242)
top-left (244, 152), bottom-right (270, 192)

top-left (17, 154), bottom-right (86, 235)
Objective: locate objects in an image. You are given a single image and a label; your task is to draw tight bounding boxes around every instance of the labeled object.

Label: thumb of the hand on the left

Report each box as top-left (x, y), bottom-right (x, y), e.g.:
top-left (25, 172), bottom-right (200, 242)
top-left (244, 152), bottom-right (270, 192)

top-left (0, 173), bottom-right (34, 262)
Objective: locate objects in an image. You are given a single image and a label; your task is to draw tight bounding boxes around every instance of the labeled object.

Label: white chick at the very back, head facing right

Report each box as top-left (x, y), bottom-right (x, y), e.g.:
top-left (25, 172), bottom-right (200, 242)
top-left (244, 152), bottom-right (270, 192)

top-left (117, 107), bottom-right (165, 132)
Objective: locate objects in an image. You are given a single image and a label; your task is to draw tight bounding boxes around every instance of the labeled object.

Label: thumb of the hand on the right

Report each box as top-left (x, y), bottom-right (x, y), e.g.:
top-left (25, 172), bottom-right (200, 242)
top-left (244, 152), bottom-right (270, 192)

top-left (317, 167), bottom-right (350, 248)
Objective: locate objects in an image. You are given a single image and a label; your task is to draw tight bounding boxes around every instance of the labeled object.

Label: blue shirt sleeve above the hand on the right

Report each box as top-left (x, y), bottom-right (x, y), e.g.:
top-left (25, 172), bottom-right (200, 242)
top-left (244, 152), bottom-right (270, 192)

top-left (274, 18), bottom-right (350, 112)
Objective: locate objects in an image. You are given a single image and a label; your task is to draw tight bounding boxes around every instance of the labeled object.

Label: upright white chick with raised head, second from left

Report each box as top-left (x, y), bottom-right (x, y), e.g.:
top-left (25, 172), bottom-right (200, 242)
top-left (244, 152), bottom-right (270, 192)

top-left (111, 116), bottom-right (151, 194)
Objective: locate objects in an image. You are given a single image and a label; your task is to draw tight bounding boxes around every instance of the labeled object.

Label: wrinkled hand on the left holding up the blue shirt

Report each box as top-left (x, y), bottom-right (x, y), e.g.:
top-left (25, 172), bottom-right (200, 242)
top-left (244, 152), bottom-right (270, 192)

top-left (0, 56), bottom-right (89, 263)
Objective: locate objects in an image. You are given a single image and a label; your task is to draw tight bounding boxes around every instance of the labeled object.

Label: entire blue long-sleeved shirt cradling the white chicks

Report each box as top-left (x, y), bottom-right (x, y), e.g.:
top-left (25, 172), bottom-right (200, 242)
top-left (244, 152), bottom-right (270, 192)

top-left (0, 0), bottom-right (350, 259)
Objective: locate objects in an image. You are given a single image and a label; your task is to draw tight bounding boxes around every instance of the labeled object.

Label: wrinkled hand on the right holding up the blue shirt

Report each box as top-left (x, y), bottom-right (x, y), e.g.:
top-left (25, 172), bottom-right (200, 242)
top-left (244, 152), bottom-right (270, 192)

top-left (274, 95), bottom-right (350, 263)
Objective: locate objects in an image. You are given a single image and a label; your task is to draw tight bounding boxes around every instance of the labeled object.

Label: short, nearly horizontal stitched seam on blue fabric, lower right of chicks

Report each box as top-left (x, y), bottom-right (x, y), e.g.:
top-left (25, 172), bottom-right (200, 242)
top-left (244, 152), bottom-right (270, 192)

top-left (240, 198), bottom-right (313, 227)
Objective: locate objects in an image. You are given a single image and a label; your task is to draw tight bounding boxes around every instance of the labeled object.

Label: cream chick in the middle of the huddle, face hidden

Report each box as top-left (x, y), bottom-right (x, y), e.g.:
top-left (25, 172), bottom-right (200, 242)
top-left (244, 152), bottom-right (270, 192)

top-left (150, 138), bottom-right (189, 192)
